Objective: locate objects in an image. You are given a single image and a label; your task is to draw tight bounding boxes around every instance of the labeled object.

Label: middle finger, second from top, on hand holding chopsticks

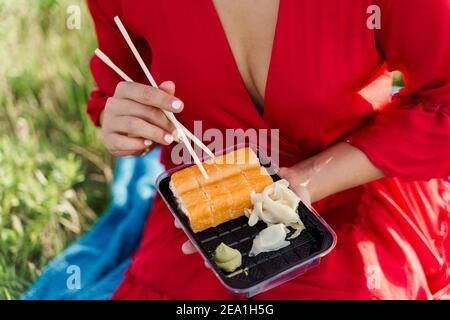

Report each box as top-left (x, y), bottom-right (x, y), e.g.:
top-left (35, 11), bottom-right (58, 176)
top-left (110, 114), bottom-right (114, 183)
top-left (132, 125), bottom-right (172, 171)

top-left (108, 98), bottom-right (175, 132)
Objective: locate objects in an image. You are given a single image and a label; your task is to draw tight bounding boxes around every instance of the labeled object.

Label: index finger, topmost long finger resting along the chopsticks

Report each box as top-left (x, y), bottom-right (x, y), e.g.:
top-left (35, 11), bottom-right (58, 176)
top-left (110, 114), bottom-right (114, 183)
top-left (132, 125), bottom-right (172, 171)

top-left (114, 82), bottom-right (183, 112)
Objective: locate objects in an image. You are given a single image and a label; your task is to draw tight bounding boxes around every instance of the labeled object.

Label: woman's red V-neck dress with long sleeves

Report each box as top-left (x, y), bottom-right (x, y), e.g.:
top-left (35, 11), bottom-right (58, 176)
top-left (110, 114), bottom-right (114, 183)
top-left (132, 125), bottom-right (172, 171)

top-left (88, 0), bottom-right (450, 299)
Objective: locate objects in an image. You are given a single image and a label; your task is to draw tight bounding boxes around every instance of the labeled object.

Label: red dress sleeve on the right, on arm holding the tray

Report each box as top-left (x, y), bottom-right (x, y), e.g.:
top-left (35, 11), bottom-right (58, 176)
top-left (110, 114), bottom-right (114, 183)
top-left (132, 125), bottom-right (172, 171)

top-left (347, 0), bottom-right (450, 180)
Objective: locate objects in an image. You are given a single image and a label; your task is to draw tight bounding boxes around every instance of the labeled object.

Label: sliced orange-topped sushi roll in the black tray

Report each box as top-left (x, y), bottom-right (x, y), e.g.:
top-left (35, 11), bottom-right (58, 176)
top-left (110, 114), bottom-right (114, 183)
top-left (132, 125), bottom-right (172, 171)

top-left (170, 148), bottom-right (273, 232)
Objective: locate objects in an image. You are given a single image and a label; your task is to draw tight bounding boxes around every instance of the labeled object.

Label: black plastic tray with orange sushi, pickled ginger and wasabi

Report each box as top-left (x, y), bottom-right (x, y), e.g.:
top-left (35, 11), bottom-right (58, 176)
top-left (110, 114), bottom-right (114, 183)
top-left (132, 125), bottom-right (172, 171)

top-left (157, 145), bottom-right (336, 297)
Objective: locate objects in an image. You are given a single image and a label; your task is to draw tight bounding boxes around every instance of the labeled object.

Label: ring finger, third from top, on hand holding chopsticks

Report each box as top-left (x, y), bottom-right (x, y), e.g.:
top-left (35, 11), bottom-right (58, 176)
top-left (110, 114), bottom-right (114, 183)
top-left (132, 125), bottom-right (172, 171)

top-left (112, 116), bottom-right (174, 145)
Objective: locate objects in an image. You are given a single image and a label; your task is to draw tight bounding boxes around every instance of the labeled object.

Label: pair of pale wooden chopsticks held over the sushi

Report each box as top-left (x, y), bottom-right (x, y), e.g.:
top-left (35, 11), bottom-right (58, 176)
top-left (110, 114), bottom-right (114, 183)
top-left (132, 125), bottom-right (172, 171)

top-left (95, 16), bottom-right (214, 179)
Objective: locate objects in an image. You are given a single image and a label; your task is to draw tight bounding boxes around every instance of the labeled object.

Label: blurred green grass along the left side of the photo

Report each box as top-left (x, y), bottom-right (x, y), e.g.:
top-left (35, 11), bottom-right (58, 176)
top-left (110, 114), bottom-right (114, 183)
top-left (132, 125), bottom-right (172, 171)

top-left (0, 0), bottom-right (112, 299)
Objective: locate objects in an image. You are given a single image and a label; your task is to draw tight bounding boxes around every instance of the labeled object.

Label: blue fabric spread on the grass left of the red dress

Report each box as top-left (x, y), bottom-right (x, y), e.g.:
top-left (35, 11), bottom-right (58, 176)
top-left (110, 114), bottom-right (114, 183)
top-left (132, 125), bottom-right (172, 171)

top-left (22, 149), bottom-right (163, 300)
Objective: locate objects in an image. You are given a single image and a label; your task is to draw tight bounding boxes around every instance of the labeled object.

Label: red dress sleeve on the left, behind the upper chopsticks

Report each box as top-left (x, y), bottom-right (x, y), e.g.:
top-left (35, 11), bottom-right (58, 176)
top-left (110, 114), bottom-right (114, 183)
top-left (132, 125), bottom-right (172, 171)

top-left (87, 0), bottom-right (151, 126)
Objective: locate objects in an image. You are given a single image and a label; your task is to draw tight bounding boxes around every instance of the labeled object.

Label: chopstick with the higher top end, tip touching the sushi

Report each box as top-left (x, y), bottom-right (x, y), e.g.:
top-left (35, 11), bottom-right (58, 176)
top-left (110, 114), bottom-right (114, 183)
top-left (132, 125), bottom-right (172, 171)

top-left (114, 16), bottom-right (209, 180)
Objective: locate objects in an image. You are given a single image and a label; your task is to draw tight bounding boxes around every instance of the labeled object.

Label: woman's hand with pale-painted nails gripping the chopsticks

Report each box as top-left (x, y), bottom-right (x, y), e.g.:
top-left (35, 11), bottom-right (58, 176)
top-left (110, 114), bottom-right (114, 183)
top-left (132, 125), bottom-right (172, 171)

top-left (100, 81), bottom-right (184, 157)
